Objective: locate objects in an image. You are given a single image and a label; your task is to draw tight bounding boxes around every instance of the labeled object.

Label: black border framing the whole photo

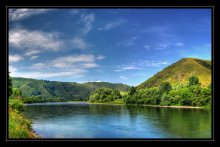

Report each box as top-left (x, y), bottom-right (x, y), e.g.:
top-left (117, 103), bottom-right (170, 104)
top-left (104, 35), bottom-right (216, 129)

top-left (0, 0), bottom-right (220, 145)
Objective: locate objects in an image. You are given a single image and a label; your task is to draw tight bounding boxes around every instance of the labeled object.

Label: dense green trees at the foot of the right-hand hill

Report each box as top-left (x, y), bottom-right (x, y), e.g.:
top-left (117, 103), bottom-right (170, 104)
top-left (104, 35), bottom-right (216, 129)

top-left (124, 76), bottom-right (211, 106)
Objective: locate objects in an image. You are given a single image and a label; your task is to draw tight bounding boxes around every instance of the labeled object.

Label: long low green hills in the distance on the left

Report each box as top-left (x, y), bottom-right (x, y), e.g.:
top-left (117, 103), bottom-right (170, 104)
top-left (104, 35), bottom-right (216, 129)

top-left (12, 77), bottom-right (130, 100)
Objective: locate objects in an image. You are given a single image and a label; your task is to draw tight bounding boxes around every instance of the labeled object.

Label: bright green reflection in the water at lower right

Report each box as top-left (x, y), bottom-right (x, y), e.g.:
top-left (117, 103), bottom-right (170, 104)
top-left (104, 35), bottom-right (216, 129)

top-left (156, 108), bottom-right (211, 138)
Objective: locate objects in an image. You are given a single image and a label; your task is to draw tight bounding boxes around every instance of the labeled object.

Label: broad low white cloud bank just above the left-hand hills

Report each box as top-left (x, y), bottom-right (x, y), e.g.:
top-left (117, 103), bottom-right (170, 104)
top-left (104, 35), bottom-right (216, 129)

top-left (9, 54), bottom-right (104, 79)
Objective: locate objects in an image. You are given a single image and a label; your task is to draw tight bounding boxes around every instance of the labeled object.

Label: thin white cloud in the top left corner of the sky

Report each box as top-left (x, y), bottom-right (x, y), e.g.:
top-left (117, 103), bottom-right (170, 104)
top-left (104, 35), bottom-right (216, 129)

top-left (9, 8), bottom-right (52, 21)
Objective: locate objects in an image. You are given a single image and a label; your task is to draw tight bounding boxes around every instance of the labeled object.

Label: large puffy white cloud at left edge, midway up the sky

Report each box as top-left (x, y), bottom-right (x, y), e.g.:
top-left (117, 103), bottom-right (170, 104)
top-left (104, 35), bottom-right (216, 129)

top-left (9, 28), bottom-right (63, 51)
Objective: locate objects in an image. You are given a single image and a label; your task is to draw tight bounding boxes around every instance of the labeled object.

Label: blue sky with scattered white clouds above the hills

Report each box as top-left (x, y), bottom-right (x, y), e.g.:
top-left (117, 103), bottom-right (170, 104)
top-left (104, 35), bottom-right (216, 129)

top-left (8, 8), bottom-right (211, 86)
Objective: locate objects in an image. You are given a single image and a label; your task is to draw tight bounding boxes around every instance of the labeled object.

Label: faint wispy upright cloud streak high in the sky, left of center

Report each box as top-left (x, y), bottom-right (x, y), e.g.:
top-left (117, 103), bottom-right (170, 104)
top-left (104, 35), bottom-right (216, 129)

top-left (80, 13), bottom-right (95, 35)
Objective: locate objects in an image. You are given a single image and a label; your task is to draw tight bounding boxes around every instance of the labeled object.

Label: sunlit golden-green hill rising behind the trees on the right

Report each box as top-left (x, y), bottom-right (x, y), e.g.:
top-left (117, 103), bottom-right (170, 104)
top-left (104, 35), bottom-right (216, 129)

top-left (137, 58), bottom-right (212, 89)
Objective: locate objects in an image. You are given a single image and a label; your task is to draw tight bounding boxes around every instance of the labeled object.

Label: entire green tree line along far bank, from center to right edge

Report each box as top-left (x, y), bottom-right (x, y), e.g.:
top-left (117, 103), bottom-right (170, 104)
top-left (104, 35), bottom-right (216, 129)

top-left (89, 76), bottom-right (211, 106)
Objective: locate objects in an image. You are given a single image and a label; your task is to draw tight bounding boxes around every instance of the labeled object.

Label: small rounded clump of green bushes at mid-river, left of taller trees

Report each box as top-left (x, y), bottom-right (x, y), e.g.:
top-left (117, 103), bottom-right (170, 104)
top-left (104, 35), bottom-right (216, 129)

top-left (89, 88), bottom-right (122, 103)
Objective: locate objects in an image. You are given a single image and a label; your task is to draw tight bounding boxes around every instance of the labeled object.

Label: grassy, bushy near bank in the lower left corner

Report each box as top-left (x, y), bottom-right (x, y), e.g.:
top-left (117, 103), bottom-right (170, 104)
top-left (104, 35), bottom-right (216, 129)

top-left (8, 98), bottom-right (40, 139)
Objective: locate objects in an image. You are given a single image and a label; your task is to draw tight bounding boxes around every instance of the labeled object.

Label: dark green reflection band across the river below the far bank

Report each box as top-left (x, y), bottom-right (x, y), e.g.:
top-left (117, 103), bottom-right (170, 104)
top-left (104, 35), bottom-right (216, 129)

top-left (25, 104), bottom-right (211, 138)
